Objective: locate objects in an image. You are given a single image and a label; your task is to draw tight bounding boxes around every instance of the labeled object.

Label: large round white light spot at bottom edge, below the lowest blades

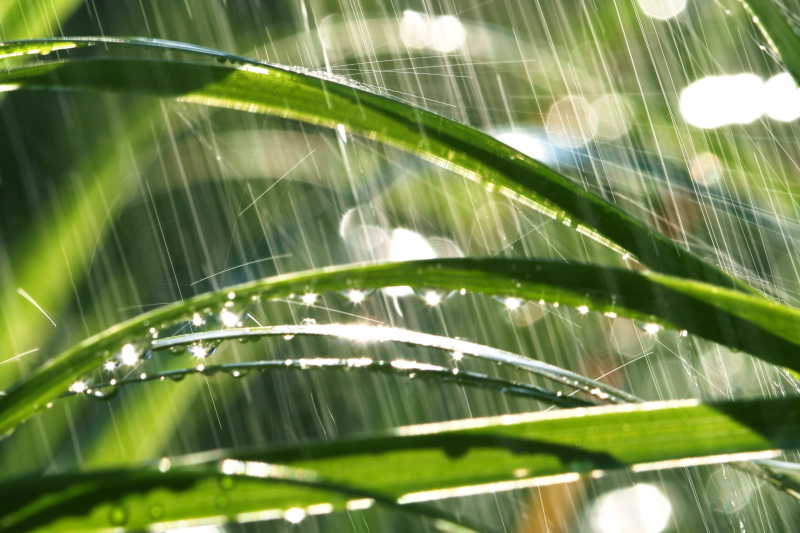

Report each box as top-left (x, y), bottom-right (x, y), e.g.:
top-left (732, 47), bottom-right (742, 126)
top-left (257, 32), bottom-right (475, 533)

top-left (590, 483), bottom-right (672, 533)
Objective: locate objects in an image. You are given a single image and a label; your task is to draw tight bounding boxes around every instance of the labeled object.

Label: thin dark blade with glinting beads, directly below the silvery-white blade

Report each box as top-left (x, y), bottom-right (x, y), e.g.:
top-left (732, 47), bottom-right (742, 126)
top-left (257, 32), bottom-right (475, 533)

top-left (70, 357), bottom-right (594, 407)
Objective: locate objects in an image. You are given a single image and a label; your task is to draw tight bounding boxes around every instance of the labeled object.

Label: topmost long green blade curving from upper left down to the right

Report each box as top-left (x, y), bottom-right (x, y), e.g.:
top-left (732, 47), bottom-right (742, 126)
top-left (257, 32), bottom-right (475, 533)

top-left (0, 37), bottom-right (755, 292)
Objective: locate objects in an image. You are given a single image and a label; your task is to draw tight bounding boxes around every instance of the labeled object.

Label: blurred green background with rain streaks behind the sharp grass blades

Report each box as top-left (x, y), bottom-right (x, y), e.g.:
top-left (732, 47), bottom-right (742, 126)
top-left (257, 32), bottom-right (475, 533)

top-left (0, 0), bottom-right (800, 533)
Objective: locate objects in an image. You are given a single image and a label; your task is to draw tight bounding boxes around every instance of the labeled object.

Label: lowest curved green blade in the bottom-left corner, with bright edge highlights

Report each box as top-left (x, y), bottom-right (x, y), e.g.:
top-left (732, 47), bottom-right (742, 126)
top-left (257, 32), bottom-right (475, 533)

top-left (0, 461), bottom-right (497, 533)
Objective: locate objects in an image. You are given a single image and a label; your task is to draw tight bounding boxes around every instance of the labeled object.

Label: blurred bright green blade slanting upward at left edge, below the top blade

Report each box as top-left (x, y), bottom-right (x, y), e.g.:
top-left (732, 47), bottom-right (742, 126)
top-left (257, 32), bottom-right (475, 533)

top-left (0, 106), bottom-right (158, 386)
